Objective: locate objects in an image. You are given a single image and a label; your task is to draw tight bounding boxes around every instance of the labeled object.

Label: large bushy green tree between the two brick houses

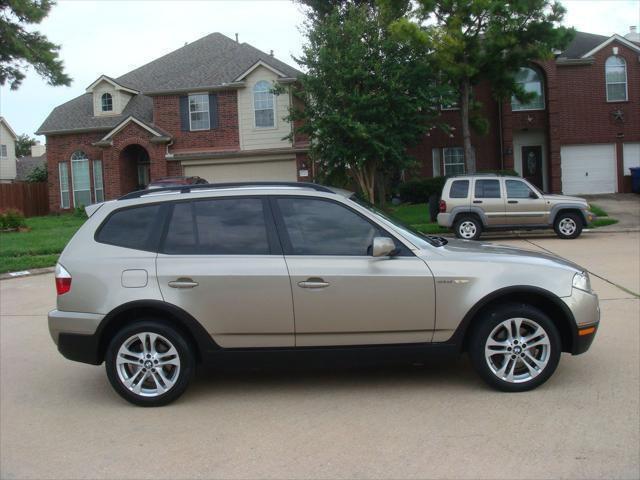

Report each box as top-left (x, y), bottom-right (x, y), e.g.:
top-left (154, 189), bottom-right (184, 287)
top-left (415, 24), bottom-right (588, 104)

top-left (289, 0), bottom-right (438, 202)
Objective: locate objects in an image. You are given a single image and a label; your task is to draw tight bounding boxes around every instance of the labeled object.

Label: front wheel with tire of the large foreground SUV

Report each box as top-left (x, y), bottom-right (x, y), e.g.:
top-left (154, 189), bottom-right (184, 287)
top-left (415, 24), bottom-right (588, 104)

top-left (469, 304), bottom-right (562, 392)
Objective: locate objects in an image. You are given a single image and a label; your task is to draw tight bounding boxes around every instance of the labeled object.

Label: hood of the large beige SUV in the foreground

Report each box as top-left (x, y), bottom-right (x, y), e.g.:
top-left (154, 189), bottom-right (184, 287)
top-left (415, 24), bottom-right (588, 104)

top-left (424, 239), bottom-right (584, 272)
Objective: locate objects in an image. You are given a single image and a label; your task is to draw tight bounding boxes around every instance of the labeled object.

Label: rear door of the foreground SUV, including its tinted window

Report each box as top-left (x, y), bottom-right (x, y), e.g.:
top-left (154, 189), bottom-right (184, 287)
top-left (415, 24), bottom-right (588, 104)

top-left (156, 197), bottom-right (294, 348)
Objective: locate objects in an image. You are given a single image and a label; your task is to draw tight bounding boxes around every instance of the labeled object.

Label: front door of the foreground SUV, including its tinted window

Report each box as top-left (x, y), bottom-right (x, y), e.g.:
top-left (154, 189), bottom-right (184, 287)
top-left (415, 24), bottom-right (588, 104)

top-left (274, 196), bottom-right (435, 346)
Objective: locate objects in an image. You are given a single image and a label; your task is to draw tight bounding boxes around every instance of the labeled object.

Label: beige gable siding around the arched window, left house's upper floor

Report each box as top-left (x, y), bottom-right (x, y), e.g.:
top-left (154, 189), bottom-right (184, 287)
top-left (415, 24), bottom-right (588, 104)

top-left (238, 67), bottom-right (291, 150)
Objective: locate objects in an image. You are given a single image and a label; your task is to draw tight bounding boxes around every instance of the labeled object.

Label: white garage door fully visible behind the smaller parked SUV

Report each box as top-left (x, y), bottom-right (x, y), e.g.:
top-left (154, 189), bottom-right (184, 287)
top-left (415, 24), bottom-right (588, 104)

top-left (560, 144), bottom-right (618, 195)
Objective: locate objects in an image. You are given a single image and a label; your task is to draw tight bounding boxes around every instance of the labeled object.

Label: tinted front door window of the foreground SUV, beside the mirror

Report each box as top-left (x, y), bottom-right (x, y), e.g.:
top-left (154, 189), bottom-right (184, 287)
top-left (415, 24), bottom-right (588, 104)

top-left (278, 198), bottom-right (379, 256)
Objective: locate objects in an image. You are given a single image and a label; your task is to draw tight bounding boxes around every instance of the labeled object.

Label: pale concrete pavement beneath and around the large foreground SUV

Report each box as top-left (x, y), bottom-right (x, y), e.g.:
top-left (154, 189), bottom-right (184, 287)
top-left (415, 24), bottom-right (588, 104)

top-left (0, 233), bottom-right (640, 479)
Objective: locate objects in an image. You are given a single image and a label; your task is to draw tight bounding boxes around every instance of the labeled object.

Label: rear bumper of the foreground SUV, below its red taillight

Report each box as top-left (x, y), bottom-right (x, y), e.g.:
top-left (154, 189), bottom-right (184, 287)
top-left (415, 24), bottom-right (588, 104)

top-left (48, 310), bottom-right (104, 365)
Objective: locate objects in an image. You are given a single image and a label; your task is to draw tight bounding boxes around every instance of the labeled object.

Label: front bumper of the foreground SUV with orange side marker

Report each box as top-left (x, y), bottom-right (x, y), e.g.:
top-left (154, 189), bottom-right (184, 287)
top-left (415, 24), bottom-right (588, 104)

top-left (562, 288), bottom-right (600, 355)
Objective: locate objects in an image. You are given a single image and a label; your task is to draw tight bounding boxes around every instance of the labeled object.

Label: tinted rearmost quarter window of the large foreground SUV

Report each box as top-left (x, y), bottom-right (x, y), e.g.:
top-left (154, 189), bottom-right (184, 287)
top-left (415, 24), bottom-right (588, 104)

top-left (96, 205), bottom-right (160, 250)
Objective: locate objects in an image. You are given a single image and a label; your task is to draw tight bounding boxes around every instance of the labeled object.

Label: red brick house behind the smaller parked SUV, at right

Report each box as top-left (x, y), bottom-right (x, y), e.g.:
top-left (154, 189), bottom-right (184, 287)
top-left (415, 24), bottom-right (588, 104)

top-left (412, 27), bottom-right (640, 194)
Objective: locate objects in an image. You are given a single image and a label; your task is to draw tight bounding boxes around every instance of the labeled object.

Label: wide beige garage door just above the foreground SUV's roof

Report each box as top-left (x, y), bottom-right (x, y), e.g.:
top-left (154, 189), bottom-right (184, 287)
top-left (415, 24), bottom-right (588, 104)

top-left (184, 159), bottom-right (297, 183)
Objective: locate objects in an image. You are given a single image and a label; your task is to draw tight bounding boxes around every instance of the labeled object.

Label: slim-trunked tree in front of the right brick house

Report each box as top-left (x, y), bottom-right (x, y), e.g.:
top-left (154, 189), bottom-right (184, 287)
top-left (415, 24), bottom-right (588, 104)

top-left (394, 0), bottom-right (573, 173)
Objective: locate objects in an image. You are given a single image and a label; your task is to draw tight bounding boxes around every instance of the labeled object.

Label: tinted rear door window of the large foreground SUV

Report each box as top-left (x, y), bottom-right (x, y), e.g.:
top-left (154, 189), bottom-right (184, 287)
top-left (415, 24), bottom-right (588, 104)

top-left (163, 198), bottom-right (270, 255)
